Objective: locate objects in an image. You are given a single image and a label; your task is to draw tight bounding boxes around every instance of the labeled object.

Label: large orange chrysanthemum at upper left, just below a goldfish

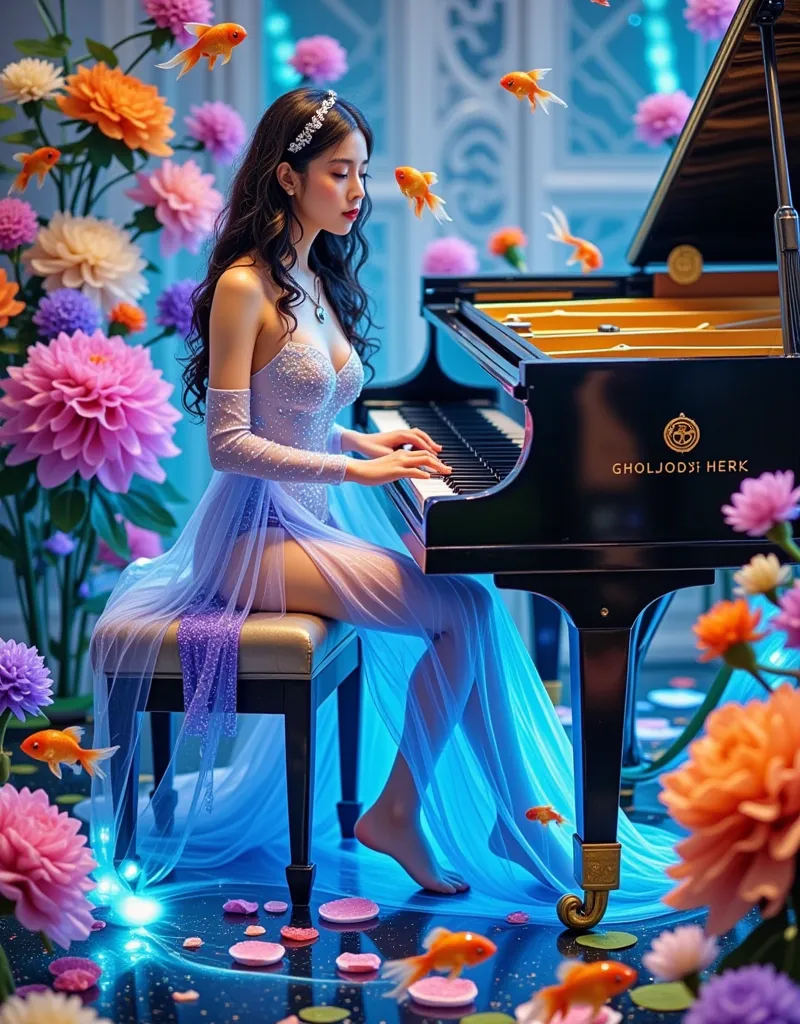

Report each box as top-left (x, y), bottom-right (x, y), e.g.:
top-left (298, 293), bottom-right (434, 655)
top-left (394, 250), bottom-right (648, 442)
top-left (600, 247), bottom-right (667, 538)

top-left (55, 61), bottom-right (175, 157)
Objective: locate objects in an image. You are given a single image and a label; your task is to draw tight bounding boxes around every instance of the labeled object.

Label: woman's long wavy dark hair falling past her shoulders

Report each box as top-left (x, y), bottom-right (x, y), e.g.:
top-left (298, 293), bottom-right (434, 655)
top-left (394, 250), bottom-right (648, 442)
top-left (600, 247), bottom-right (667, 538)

top-left (183, 87), bottom-right (379, 418)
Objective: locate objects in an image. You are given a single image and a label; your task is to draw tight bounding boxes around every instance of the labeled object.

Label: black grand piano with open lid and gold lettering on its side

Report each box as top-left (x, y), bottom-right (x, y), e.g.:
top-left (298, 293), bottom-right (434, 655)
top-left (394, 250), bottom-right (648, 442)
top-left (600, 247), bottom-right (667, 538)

top-left (355, 0), bottom-right (800, 930)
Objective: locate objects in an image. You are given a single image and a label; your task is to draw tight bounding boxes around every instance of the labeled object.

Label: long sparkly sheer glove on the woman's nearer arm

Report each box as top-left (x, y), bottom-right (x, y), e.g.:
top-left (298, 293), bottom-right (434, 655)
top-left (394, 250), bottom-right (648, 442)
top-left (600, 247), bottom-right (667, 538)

top-left (206, 387), bottom-right (347, 483)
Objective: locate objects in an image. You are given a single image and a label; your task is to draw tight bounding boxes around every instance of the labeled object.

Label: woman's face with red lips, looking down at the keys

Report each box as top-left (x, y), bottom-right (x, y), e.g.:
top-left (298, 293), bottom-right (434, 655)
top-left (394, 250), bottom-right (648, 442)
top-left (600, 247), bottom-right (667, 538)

top-left (286, 131), bottom-right (368, 234)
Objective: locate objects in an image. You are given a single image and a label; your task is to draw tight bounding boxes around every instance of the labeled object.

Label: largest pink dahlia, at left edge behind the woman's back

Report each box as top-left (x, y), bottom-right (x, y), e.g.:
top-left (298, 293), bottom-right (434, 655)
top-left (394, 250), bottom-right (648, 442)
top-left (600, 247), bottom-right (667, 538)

top-left (0, 331), bottom-right (180, 492)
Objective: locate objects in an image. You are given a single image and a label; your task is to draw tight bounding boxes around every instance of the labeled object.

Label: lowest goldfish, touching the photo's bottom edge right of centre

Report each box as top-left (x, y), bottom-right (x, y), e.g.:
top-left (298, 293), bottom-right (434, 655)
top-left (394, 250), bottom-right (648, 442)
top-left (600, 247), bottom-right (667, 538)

top-left (516, 961), bottom-right (638, 1024)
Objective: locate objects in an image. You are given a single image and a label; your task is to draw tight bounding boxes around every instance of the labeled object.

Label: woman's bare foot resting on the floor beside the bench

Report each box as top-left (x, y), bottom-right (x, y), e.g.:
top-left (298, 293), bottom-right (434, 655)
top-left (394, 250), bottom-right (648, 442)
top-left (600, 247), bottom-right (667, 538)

top-left (355, 802), bottom-right (469, 896)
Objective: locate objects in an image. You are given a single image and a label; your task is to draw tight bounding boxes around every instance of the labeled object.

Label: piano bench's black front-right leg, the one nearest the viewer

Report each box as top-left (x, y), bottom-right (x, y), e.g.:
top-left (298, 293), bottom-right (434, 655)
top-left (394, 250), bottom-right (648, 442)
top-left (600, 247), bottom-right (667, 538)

top-left (284, 683), bottom-right (317, 906)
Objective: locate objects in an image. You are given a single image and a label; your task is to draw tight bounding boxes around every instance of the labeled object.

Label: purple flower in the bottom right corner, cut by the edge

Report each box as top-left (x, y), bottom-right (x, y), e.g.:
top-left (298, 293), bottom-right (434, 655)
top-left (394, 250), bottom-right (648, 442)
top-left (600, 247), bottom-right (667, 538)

top-left (683, 964), bottom-right (800, 1024)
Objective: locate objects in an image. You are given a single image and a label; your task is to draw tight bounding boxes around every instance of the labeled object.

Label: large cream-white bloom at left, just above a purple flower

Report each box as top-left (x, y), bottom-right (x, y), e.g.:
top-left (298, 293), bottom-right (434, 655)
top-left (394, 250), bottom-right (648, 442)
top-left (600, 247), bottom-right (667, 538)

top-left (24, 212), bottom-right (149, 312)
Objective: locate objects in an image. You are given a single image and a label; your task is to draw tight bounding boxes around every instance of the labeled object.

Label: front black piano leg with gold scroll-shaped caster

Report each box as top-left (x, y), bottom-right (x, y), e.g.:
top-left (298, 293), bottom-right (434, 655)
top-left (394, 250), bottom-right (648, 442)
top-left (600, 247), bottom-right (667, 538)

top-left (495, 569), bottom-right (714, 931)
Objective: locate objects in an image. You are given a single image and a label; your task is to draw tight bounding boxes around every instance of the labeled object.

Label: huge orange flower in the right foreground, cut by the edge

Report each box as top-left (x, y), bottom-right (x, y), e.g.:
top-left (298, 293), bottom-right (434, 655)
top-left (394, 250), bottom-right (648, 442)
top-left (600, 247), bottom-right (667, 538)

top-left (660, 684), bottom-right (800, 935)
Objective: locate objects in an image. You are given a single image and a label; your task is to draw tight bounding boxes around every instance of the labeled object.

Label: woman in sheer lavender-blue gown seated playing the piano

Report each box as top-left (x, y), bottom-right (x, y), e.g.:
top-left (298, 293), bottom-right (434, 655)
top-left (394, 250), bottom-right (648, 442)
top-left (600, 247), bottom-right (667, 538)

top-left (93, 88), bottom-right (672, 921)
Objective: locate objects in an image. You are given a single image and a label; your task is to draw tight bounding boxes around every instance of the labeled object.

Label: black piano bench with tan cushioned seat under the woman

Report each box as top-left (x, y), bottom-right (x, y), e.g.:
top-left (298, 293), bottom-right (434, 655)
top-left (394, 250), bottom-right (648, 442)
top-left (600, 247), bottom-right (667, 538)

top-left (102, 612), bottom-right (361, 906)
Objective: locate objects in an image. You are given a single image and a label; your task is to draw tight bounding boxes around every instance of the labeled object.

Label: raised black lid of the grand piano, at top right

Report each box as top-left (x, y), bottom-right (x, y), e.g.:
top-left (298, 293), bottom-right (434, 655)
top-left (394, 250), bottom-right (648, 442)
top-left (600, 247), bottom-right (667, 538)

top-left (628, 0), bottom-right (800, 266)
